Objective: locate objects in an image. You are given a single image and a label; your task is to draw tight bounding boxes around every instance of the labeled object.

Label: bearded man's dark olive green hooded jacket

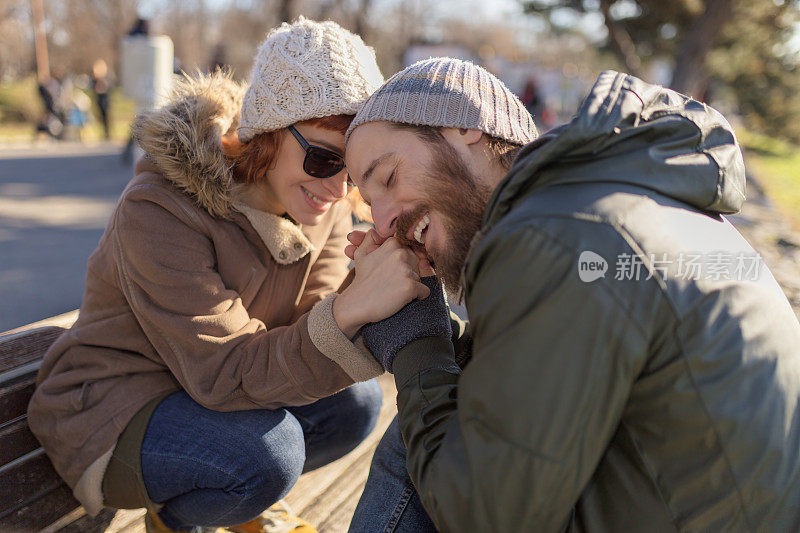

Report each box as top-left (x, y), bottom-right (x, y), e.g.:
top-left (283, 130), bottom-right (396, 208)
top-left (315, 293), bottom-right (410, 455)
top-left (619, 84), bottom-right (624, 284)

top-left (394, 72), bottom-right (800, 532)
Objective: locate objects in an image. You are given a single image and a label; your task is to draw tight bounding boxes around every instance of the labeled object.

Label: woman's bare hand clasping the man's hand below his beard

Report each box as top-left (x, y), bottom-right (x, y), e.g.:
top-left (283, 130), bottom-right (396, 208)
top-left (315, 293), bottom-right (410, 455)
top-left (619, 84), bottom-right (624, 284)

top-left (333, 230), bottom-right (430, 337)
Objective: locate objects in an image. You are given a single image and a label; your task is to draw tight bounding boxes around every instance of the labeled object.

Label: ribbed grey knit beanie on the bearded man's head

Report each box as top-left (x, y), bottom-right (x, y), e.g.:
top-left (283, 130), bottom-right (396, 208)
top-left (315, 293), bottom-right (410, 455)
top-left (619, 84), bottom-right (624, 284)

top-left (345, 57), bottom-right (539, 144)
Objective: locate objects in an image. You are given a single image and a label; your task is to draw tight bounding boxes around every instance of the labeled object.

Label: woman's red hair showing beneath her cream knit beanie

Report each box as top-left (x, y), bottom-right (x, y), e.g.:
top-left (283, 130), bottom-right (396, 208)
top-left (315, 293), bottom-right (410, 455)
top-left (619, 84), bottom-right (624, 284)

top-left (222, 115), bottom-right (369, 220)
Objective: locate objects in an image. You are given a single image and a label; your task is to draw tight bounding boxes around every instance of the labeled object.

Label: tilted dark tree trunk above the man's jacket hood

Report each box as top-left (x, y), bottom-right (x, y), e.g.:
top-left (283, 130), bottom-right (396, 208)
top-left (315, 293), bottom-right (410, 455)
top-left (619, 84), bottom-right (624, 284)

top-left (669, 0), bottom-right (734, 97)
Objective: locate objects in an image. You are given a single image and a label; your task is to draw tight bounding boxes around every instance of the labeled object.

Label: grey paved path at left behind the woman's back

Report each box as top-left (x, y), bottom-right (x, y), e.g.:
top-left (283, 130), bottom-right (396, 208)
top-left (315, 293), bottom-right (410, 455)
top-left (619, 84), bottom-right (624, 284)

top-left (0, 144), bottom-right (131, 331)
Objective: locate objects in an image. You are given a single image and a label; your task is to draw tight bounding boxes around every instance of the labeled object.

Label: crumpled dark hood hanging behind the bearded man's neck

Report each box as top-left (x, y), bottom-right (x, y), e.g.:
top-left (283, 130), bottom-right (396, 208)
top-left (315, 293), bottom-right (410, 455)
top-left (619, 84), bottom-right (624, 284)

top-left (484, 71), bottom-right (745, 224)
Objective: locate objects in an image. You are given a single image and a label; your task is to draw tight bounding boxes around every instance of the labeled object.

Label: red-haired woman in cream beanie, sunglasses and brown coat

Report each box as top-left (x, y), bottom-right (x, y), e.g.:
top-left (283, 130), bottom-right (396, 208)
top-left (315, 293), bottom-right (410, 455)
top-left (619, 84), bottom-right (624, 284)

top-left (28, 18), bottom-right (428, 532)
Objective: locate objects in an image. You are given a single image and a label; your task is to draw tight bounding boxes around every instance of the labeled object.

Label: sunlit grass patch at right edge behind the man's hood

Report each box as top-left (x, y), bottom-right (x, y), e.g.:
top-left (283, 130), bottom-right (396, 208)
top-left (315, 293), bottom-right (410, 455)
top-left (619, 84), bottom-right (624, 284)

top-left (737, 130), bottom-right (800, 231)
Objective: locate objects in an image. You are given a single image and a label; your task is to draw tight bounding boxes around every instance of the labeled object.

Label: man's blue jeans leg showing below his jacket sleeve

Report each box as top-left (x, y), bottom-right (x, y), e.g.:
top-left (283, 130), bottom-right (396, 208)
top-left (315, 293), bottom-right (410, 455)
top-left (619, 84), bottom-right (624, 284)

top-left (350, 417), bottom-right (436, 533)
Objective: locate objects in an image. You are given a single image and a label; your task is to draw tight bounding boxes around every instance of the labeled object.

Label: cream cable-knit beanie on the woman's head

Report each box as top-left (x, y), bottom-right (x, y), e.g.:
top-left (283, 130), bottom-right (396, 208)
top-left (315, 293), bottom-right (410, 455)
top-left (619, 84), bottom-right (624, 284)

top-left (238, 17), bottom-right (383, 142)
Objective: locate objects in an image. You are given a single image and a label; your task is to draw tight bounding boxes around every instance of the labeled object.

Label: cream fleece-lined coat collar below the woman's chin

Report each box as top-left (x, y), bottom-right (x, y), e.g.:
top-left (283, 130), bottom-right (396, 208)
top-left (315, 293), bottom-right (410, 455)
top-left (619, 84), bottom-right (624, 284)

top-left (234, 202), bottom-right (314, 265)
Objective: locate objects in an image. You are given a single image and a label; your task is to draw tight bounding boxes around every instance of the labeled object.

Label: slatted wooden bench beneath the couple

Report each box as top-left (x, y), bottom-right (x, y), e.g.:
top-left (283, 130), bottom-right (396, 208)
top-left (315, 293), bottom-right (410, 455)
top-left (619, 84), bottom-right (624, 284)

top-left (0, 311), bottom-right (397, 533)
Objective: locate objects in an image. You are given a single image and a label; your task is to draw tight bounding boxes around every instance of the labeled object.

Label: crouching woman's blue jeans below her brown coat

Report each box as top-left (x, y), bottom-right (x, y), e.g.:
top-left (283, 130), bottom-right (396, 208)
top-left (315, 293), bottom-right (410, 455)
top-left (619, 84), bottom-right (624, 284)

top-left (141, 379), bottom-right (383, 529)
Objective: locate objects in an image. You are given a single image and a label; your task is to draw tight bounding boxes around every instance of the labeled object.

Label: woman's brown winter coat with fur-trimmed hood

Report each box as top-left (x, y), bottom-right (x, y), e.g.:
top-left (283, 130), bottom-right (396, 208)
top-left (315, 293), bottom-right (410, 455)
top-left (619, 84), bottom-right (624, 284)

top-left (28, 72), bottom-right (382, 513)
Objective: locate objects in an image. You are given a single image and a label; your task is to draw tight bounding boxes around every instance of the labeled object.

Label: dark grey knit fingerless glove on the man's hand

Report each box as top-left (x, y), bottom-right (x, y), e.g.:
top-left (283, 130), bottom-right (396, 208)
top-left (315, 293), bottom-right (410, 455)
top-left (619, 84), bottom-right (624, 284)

top-left (361, 276), bottom-right (452, 372)
